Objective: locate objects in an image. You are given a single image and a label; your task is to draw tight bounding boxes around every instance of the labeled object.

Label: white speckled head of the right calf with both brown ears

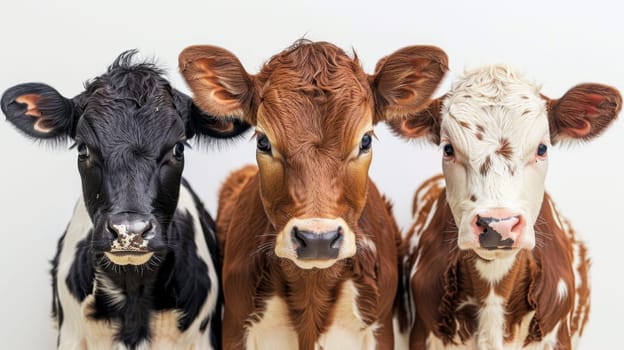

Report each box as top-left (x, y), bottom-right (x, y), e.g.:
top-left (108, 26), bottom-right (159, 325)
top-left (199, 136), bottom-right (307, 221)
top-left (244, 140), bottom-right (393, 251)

top-left (390, 66), bottom-right (622, 259)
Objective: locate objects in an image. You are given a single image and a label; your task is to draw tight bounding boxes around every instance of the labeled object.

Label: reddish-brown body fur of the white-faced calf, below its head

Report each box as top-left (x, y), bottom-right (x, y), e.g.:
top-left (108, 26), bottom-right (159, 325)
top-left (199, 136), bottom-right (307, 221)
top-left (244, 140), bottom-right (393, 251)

top-left (404, 177), bottom-right (589, 349)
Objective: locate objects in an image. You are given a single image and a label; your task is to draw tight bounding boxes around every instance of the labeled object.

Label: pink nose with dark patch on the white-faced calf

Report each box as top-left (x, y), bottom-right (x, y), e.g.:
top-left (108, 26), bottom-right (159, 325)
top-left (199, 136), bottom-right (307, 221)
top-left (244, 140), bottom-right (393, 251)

top-left (471, 209), bottom-right (526, 249)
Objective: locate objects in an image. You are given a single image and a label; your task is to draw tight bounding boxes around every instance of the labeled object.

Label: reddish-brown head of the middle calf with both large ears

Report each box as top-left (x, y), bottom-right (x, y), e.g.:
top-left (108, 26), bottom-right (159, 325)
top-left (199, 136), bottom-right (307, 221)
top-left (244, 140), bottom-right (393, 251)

top-left (179, 40), bottom-right (447, 268)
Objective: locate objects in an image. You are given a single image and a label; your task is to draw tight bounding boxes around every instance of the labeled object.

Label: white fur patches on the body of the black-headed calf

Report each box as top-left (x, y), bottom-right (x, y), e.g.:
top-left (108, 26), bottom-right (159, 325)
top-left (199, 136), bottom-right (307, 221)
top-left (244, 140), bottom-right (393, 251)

top-left (57, 186), bottom-right (219, 350)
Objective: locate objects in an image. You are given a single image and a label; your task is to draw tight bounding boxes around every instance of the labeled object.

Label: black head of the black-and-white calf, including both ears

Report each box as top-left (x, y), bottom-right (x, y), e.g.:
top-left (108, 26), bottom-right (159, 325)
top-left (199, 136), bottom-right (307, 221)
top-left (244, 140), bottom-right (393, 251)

top-left (1, 51), bottom-right (248, 267)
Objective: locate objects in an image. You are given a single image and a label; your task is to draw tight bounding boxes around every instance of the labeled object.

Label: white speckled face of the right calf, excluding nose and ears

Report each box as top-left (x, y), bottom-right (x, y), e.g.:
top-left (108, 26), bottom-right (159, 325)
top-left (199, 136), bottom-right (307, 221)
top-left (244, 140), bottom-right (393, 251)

top-left (441, 66), bottom-right (550, 254)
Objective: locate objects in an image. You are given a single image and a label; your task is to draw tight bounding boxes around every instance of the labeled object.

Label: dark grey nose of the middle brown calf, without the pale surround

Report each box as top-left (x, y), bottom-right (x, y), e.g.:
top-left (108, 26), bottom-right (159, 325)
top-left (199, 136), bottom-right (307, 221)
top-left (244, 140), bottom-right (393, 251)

top-left (291, 227), bottom-right (343, 260)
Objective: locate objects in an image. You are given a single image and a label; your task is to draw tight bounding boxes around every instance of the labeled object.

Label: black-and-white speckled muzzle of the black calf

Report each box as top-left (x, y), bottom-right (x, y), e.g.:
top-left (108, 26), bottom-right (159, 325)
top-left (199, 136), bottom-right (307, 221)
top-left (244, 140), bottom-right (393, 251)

top-left (104, 213), bottom-right (157, 265)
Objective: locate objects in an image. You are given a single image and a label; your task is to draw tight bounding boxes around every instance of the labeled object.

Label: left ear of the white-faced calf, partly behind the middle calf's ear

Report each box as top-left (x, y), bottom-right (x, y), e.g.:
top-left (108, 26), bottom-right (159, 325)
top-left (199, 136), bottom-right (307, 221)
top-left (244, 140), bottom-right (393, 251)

top-left (386, 96), bottom-right (445, 144)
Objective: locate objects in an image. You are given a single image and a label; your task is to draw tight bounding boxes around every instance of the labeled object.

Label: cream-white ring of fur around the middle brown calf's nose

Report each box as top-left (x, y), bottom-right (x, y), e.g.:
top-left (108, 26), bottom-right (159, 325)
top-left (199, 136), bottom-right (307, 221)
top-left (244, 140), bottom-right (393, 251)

top-left (275, 218), bottom-right (356, 269)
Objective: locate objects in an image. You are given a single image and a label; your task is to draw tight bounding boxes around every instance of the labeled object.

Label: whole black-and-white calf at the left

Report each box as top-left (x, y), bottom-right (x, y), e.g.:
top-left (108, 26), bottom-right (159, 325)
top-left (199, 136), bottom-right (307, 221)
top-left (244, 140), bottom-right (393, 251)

top-left (1, 50), bottom-right (249, 349)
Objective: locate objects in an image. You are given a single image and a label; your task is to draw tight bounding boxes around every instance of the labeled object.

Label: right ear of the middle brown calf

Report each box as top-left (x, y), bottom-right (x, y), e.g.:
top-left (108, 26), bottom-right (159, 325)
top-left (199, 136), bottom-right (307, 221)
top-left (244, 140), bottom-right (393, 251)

top-left (369, 46), bottom-right (448, 122)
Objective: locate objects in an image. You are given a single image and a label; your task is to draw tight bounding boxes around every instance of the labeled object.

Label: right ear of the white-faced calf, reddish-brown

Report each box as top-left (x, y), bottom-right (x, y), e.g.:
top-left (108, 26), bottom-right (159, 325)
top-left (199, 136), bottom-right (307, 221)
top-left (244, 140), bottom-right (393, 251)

top-left (542, 84), bottom-right (622, 144)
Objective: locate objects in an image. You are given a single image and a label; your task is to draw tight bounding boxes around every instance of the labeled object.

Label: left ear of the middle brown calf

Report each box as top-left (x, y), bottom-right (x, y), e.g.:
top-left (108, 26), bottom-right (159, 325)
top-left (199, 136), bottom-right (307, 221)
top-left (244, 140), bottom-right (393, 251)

top-left (178, 46), bottom-right (255, 124)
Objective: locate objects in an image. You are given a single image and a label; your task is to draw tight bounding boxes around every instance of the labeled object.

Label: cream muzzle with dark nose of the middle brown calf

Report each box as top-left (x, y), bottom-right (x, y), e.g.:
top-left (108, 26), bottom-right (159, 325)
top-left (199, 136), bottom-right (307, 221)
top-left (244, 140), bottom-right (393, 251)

top-left (275, 218), bottom-right (356, 269)
